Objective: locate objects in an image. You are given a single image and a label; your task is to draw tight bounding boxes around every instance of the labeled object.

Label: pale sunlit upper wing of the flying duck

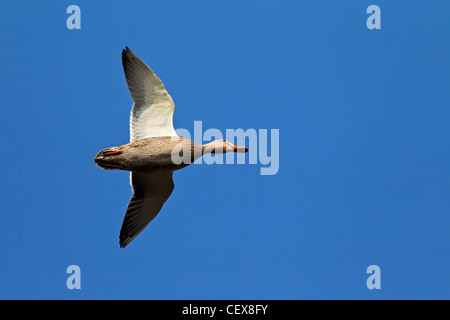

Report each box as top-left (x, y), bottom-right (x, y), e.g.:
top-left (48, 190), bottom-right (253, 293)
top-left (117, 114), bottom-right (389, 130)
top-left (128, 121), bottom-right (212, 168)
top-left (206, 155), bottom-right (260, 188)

top-left (122, 48), bottom-right (177, 141)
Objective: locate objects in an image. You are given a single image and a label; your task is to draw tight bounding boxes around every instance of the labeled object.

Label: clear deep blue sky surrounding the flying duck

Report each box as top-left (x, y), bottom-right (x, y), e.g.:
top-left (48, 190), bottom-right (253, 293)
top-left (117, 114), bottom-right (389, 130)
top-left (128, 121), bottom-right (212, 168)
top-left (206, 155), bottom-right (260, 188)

top-left (0, 0), bottom-right (450, 299)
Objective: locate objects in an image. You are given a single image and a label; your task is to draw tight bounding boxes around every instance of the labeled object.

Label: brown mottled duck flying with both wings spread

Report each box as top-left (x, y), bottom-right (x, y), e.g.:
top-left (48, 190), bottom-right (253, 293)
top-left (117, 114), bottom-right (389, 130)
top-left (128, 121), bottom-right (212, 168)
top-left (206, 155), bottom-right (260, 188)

top-left (94, 47), bottom-right (248, 248)
